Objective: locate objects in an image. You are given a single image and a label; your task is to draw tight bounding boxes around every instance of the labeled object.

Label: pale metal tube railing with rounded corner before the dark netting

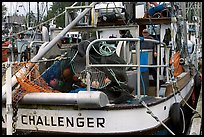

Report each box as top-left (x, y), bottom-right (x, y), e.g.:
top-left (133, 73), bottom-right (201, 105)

top-left (86, 38), bottom-right (169, 97)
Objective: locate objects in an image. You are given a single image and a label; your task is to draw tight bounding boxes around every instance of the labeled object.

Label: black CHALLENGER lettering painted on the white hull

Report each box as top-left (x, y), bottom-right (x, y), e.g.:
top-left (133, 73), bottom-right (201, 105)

top-left (2, 115), bottom-right (105, 128)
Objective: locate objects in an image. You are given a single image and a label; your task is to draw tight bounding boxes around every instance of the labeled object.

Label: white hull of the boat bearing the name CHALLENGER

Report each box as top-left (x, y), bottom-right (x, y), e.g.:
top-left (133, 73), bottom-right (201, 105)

top-left (2, 79), bottom-right (194, 134)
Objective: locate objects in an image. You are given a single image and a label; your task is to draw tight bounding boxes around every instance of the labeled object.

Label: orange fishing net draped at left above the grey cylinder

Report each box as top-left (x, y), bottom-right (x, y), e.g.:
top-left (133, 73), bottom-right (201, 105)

top-left (13, 62), bottom-right (59, 104)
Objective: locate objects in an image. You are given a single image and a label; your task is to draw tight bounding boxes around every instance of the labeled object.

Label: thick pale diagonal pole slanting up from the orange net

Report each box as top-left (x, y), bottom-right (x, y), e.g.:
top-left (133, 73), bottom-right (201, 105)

top-left (2, 2), bottom-right (97, 100)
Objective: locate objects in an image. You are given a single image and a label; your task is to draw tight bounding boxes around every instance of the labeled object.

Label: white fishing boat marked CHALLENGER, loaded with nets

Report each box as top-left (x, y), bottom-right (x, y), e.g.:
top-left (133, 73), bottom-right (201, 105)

top-left (2, 2), bottom-right (201, 135)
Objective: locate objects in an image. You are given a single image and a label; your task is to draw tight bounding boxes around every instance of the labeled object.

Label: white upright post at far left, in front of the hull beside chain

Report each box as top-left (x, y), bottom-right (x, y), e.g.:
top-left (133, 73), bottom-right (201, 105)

top-left (6, 63), bottom-right (13, 135)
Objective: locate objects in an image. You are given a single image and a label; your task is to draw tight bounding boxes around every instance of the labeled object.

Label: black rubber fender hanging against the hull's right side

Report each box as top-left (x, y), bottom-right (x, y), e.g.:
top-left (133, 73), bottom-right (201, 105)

top-left (169, 103), bottom-right (185, 134)
